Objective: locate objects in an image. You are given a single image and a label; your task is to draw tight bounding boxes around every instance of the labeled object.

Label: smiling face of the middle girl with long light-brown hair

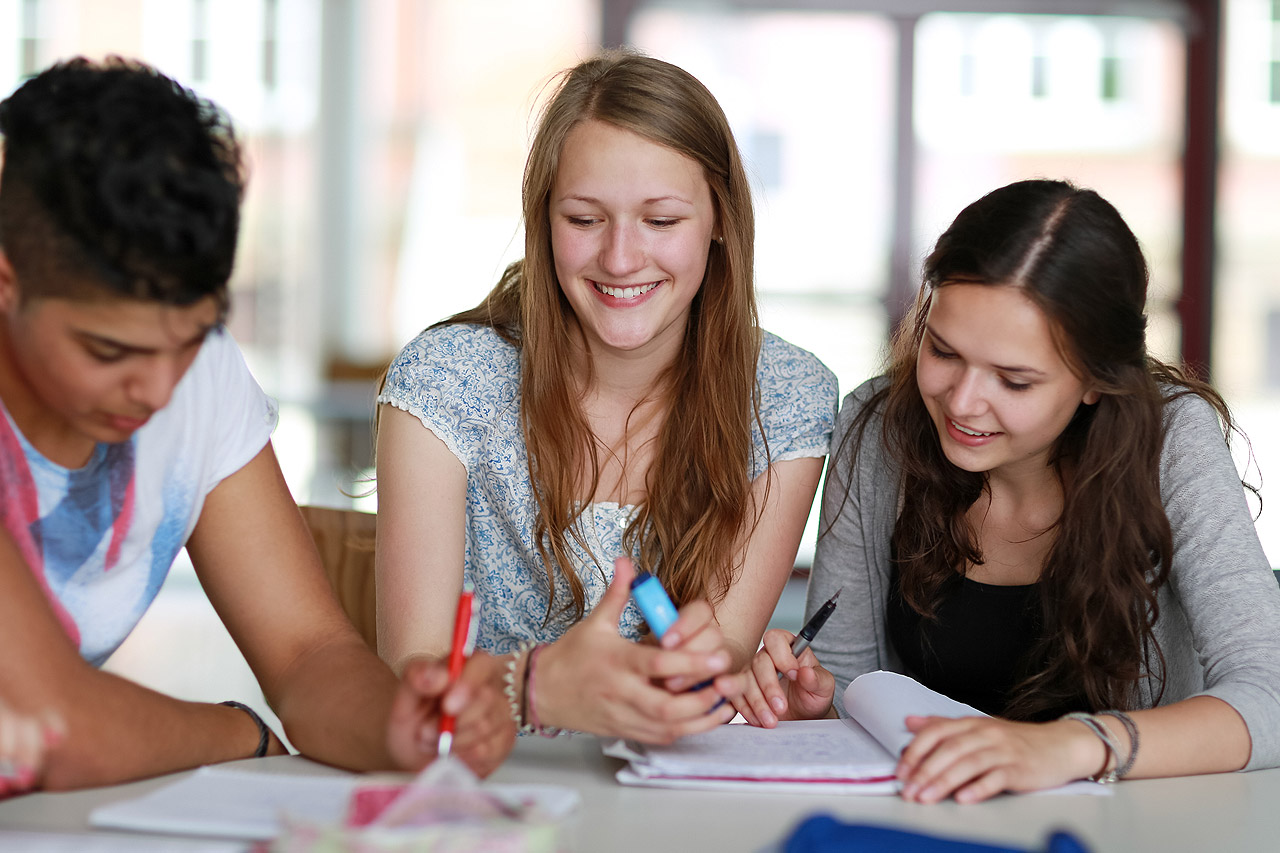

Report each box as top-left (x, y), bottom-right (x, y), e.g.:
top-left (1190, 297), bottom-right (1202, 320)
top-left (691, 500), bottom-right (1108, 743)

top-left (548, 120), bottom-right (716, 360)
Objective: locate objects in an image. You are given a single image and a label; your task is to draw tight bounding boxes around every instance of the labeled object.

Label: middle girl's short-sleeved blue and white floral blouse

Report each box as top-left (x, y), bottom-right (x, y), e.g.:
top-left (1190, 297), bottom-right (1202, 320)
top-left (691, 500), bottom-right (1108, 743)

top-left (378, 325), bottom-right (836, 654)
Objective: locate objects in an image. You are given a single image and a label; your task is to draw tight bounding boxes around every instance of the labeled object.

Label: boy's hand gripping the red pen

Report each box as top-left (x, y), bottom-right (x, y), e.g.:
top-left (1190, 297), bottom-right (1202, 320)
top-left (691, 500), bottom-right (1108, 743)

top-left (387, 651), bottom-right (516, 776)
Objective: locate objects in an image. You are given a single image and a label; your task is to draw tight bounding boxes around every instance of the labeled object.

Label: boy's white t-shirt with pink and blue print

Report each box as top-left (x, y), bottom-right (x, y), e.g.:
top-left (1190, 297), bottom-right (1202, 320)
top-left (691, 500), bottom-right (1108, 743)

top-left (0, 330), bottom-right (276, 666)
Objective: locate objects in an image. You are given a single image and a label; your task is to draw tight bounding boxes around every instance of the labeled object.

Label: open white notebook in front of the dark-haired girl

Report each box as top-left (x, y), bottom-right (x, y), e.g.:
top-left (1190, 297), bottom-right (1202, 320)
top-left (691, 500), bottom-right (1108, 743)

top-left (605, 672), bottom-right (1105, 794)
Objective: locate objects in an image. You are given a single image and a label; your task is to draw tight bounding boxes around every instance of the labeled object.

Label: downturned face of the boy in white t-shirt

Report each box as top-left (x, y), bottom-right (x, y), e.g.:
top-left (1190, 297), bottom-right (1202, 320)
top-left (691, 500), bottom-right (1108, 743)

top-left (0, 257), bottom-right (219, 467)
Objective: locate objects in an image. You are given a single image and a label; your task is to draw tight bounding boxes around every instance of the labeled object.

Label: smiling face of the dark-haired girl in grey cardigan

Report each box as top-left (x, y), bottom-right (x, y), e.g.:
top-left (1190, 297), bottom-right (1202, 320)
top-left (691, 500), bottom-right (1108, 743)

top-left (915, 284), bottom-right (1098, 476)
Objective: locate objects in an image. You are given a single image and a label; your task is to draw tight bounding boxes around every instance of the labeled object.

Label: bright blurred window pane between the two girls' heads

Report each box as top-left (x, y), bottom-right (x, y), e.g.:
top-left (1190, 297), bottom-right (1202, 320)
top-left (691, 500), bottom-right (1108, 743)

top-left (630, 6), bottom-right (896, 392)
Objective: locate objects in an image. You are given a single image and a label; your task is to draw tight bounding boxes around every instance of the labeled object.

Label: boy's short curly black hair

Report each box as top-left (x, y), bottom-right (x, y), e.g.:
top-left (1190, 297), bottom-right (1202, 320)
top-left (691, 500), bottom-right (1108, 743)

top-left (0, 56), bottom-right (244, 314)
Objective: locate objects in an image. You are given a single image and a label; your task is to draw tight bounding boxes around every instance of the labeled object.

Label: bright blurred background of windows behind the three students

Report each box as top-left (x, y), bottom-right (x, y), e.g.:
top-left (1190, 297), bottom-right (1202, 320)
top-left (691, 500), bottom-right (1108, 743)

top-left (0, 0), bottom-right (1280, 722)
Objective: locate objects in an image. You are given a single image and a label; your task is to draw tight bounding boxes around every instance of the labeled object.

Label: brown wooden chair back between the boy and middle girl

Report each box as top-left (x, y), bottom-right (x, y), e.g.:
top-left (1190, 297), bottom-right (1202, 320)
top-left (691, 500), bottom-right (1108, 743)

top-left (298, 506), bottom-right (378, 653)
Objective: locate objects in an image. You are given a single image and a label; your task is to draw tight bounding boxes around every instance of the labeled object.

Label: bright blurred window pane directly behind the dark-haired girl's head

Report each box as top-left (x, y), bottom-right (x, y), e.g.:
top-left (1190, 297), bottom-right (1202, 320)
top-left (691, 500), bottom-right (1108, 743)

top-left (913, 13), bottom-right (1185, 360)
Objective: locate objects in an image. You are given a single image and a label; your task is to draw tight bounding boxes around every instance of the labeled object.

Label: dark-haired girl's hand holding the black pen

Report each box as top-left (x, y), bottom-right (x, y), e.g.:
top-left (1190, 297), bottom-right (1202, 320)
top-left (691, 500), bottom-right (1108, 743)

top-left (731, 629), bottom-right (836, 729)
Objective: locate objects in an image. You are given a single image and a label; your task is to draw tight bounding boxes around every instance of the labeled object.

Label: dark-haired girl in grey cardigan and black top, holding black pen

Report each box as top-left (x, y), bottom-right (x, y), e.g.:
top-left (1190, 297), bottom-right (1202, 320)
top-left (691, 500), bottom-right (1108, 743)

top-left (740, 181), bottom-right (1280, 802)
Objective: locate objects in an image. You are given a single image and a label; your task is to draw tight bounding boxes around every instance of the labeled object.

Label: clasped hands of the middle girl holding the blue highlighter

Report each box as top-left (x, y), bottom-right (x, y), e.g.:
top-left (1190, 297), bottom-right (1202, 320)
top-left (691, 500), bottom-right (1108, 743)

top-left (522, 558), bottom-right (744, 743)
